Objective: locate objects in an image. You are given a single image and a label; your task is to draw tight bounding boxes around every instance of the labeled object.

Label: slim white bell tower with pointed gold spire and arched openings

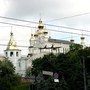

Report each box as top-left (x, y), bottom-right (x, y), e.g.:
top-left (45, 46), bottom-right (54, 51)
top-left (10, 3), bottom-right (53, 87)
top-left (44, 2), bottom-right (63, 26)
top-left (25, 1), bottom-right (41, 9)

top-left (4, 31), bottom-right (21, 73)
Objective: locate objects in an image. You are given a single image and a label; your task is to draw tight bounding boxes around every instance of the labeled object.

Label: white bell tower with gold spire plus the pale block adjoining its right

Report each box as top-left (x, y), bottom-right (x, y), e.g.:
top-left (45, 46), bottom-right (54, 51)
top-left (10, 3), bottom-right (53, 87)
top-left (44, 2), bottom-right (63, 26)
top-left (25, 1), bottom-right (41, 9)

top-left (4, 32), bottom-right (27, 76)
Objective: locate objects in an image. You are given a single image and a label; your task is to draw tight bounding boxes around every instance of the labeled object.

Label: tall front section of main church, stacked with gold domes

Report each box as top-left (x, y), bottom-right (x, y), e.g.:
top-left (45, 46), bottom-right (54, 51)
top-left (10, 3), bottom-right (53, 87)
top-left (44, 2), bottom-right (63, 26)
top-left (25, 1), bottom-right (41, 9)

top-left (28, 19), bottom-right (48, 63)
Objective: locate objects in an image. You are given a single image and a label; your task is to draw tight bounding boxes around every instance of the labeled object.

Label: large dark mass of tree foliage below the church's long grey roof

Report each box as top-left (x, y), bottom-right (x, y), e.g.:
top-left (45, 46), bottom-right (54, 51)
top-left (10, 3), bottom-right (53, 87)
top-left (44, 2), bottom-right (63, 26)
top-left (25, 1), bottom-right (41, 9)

top-left (26, 44), bottom-right (90, 90)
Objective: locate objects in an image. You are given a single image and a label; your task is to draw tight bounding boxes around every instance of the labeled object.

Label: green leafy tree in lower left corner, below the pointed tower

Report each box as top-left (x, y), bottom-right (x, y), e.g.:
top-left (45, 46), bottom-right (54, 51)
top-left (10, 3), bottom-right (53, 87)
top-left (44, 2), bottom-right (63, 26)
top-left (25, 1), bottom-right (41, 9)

top-left (0, 59), bottom-right (21, 90)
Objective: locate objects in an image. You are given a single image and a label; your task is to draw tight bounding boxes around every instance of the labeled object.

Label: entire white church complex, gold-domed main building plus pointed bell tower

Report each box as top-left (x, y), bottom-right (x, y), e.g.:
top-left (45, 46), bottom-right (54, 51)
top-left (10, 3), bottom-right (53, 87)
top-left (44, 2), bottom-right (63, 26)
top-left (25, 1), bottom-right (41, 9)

top-left (4, 19), bottom-right (77, 76)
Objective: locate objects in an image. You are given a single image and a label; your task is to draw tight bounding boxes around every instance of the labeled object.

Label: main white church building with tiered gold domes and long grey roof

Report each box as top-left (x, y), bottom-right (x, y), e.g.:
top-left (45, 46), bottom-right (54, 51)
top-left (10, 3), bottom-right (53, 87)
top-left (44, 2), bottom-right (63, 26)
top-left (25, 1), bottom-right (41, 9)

top-left (28, 19), bottom-right (71, 65)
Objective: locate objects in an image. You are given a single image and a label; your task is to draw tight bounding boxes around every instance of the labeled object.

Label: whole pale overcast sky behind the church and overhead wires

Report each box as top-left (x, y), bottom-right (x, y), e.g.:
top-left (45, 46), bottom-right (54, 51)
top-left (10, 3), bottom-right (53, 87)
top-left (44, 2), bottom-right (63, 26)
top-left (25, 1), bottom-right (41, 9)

top-left (0, 0), bottom-right (90, 54)
